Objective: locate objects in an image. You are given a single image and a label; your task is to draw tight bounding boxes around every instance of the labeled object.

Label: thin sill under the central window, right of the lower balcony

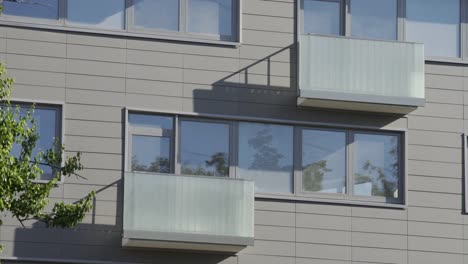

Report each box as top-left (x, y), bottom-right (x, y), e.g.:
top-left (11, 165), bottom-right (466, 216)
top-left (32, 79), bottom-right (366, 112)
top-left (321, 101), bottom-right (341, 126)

top-left (255, 193), bottom-right (408, 210)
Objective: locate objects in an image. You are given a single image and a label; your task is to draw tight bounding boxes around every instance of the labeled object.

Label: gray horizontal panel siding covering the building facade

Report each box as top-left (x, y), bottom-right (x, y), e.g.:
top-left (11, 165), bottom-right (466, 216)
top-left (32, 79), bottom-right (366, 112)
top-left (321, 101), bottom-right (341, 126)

top-left (0, 0), bottom-right (468, 264)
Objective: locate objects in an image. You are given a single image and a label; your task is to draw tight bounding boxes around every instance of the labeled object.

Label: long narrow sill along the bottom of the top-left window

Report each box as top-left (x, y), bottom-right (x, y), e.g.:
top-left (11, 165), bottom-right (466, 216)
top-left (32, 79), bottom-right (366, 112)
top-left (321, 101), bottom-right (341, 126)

top-left (0, 19), bottom-right (241, 48)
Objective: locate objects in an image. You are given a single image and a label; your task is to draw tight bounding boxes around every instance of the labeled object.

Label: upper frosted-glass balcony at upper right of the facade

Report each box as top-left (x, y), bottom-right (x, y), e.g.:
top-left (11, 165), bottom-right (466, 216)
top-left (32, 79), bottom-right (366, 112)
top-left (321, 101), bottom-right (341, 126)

top-left (297, 35), bottom-right (425, 114)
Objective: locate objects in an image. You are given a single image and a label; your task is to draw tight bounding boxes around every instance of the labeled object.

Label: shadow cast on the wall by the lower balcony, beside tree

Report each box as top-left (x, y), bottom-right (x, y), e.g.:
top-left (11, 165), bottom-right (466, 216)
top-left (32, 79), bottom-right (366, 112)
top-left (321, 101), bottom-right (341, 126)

top-left (11, 175), bottom-right (236, 264)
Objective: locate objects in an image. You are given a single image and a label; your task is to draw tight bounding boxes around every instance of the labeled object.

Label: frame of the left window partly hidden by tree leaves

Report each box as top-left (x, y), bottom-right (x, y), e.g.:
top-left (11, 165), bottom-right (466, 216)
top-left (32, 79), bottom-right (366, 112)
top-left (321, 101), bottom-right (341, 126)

top-left (10, 98), bottom-right (66, 184)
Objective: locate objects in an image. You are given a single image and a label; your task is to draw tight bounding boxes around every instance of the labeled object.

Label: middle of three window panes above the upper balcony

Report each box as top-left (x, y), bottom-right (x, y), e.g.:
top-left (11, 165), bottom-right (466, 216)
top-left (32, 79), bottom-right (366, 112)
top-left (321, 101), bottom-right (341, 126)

top-left (351, 0), bottom-right (397, 40)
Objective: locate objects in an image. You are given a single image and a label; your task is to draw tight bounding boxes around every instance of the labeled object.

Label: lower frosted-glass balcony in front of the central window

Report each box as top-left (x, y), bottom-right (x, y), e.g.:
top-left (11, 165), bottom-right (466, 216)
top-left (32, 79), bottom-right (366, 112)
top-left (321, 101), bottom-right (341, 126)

top-left (122, 172), bottom-right (254, 253)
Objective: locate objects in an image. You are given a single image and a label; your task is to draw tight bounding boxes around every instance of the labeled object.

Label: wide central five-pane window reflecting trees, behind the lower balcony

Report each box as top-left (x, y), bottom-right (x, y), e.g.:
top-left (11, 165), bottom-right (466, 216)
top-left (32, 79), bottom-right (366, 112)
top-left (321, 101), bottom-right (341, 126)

top-left (127, 110), bottom-right (405, 204)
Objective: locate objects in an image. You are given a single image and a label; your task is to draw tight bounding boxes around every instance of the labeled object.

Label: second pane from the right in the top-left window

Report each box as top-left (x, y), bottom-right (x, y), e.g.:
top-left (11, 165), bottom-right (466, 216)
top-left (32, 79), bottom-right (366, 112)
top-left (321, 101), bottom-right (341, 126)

top-left (133, 0), bottom-right (179, 31)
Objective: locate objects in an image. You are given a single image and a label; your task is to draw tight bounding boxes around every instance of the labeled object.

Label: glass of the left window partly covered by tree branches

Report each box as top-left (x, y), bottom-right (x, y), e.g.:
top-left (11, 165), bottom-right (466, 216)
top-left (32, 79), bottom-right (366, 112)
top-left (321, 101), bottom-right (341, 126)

top-left (6, 103), bottom-right (62, 180)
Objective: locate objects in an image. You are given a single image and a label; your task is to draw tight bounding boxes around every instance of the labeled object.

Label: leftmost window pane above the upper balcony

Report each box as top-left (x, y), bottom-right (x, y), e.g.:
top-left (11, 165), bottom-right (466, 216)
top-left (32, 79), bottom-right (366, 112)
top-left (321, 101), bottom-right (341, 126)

top-left (303, 0), bottom-right (341, 35)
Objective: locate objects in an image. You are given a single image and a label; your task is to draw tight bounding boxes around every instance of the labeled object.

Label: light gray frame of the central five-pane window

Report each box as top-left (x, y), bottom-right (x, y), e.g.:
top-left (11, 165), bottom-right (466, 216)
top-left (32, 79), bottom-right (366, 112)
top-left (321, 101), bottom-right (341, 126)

top-left (123, 108), bottom-right (408, 209)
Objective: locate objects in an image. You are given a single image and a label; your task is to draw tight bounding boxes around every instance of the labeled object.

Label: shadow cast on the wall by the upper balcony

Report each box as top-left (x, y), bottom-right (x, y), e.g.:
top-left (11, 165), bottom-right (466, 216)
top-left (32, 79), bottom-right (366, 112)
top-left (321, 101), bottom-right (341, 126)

top-left (189, 41), bottom-right (402, 128)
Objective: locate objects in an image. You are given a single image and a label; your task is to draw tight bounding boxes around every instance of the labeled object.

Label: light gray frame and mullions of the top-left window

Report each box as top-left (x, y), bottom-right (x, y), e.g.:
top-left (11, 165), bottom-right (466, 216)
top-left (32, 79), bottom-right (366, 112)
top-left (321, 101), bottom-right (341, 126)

top-left (0, 0), bottom-right (243, 46)
